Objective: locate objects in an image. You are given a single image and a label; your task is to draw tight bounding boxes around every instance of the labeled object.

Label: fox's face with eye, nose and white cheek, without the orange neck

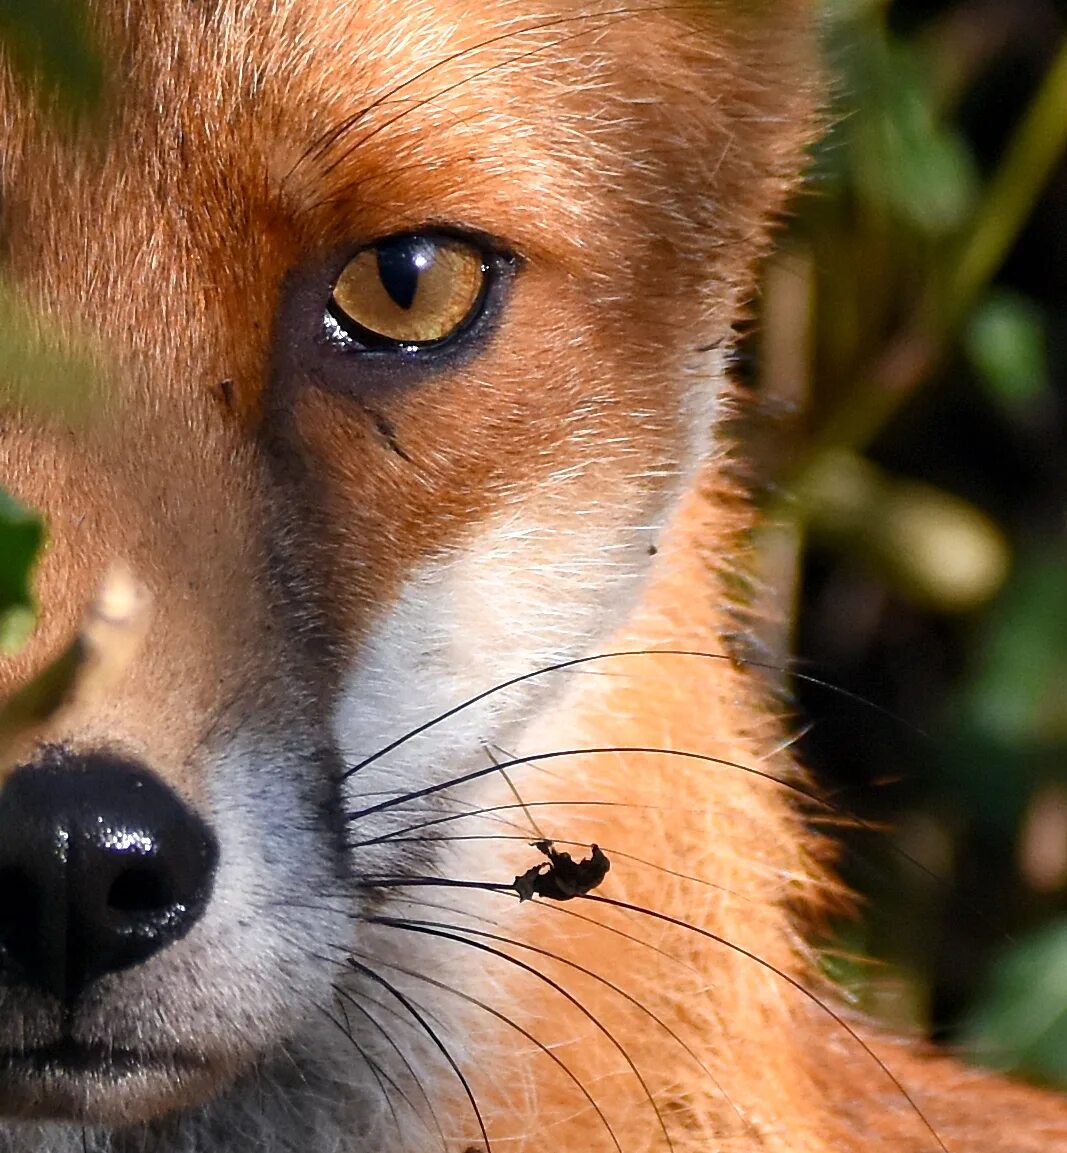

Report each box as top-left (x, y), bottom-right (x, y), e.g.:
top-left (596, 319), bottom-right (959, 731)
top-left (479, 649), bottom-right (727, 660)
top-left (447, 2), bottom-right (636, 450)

top-left (0, 2), bottom-right (811, 1151)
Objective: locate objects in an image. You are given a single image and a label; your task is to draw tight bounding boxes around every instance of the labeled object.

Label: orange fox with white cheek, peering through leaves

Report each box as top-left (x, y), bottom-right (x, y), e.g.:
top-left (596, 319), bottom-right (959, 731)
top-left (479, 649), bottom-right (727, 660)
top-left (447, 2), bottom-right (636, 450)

top-left (0, 0), bottom-right (1067, 1153)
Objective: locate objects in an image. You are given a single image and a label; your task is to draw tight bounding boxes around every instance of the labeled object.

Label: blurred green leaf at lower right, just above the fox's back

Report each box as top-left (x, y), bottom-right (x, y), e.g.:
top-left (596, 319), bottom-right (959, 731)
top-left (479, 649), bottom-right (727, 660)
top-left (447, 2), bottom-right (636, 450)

top-left (963, 919), bottom-right (1067, 1083)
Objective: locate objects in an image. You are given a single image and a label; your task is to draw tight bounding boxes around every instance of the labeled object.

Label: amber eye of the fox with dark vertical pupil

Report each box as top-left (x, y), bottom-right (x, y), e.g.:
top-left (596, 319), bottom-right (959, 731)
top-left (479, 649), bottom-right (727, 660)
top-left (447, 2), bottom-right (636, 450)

top-left (326, 234), bottom-right (490, 352)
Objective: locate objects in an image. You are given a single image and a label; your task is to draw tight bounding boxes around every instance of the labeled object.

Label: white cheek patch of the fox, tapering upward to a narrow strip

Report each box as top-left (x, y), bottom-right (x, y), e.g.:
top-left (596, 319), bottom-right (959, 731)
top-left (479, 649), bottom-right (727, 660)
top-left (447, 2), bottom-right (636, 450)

top-left (333, 349), bottom-right (724, 820)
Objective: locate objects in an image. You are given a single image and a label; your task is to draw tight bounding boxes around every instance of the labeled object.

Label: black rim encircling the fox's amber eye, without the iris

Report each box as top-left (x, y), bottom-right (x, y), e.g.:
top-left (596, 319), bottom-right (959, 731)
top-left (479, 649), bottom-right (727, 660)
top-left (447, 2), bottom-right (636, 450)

top-left (323, 227), bottom-right (519, 360)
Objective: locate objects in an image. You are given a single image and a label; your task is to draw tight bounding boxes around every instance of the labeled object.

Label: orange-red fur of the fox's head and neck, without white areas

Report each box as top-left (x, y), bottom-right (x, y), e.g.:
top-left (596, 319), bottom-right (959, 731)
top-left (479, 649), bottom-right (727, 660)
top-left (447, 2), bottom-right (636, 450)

top-left (0, 0), bottom-right (1067, 1153)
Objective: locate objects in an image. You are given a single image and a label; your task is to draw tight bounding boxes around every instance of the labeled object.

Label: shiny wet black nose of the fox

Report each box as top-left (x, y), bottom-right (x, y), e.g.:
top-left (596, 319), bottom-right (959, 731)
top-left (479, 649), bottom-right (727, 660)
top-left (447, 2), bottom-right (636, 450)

top-left (0, 754), bottom-right (218, 1003)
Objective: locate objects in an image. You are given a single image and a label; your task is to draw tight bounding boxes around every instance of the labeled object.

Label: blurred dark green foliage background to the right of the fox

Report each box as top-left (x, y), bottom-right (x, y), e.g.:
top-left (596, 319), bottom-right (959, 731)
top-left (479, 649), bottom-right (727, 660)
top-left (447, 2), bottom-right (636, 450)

top-left (753, 0), bottom-right (1067, 1084)
